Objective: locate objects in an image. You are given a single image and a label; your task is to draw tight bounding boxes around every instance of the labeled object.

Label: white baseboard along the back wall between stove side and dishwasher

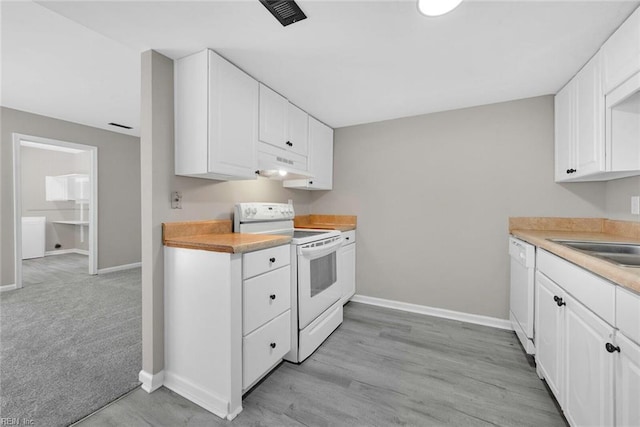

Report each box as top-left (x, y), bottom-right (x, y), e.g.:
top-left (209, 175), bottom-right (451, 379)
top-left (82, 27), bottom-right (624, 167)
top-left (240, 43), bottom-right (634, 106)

top-left (351, 295), bottom-right (513, 331)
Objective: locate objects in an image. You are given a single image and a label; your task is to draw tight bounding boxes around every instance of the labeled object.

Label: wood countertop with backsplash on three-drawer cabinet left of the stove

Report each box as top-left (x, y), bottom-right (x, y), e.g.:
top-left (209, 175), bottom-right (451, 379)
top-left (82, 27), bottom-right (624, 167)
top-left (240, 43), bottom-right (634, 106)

top-left (162, 220), bottom-right (291, 254)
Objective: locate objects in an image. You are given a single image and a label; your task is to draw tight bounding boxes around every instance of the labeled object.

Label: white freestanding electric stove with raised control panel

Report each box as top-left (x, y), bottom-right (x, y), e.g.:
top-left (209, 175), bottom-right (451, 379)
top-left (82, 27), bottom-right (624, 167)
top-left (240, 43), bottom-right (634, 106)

top-left (234, 203), bottom-right (342, 363)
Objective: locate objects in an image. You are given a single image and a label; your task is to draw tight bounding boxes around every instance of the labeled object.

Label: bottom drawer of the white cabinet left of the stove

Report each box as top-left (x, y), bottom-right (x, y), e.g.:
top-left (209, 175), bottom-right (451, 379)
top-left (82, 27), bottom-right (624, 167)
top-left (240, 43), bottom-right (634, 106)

top-left (242, 310), bottom-right (291, 390)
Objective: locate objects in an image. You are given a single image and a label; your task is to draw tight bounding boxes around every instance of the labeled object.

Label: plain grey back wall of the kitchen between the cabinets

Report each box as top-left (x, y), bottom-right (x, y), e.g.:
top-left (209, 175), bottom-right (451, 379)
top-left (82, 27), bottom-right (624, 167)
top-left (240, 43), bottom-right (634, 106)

top-left (310, 96), bottom-right (606, 319)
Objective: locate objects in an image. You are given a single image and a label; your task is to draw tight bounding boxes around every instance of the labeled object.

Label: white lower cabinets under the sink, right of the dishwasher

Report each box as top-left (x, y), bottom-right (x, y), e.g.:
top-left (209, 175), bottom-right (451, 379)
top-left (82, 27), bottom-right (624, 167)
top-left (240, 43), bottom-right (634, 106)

top-left (535, 250), bottom-right (640, 426)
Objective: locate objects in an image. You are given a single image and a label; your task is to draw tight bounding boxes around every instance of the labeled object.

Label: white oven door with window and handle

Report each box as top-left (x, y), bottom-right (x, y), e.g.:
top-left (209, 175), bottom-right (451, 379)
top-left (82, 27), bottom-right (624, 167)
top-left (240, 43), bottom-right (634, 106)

top-left (297, 236), bottom-right (342, 329)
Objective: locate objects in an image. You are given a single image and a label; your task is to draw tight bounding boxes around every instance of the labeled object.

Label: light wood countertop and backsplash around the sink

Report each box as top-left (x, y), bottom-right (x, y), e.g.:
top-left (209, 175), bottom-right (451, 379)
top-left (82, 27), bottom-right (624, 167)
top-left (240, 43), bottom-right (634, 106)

top-left (509, 219), bottom-right (640, 293)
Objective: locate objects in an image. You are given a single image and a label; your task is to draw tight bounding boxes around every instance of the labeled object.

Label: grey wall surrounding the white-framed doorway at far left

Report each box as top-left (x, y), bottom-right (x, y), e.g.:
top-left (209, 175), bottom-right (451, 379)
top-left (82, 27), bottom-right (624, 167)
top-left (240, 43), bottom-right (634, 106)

top-left (0, 107), bottom-right (140, 285)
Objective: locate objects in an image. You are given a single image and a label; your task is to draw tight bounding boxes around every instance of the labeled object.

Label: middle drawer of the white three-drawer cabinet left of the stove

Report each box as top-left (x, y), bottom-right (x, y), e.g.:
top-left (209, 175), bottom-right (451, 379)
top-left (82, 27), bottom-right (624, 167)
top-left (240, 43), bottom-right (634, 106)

top-left (242, 265), bottom-right (291, 335)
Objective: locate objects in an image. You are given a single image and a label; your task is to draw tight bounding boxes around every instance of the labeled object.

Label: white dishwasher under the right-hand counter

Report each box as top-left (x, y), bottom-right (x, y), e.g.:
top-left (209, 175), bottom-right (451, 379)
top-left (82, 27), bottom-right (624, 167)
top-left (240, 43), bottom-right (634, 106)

top-left (509, 237), bottom-right (536, 354)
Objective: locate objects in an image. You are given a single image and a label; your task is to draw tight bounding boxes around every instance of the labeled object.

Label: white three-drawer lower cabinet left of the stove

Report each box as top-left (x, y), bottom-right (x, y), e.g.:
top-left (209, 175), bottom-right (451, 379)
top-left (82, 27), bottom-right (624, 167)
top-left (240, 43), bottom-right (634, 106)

top-left (163, 245), bottom-right (291, 420)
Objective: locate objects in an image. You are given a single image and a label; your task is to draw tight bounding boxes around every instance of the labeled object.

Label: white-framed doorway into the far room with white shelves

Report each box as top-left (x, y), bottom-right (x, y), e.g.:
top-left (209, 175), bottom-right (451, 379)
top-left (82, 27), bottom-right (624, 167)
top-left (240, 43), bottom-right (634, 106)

top-left (13, 133), bottom-right (98, 289)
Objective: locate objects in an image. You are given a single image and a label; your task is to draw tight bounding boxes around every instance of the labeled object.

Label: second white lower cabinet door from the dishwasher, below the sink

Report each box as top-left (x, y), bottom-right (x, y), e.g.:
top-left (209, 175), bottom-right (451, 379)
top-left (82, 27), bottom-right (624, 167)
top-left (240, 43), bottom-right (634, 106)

top-left (563, 297), bottom-right (615, 426)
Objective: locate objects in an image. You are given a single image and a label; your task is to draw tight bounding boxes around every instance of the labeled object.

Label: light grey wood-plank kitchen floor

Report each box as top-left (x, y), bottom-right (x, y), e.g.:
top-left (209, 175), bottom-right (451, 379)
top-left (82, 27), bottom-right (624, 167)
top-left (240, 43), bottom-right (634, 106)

top-left (75, 303), bottom-right (566, 427)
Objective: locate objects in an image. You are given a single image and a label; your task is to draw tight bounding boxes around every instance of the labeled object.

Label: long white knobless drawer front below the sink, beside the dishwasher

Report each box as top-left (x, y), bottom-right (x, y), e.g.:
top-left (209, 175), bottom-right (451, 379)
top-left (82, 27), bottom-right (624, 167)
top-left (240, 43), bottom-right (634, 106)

top-left (536, 250), bottom-right (616, 325)
